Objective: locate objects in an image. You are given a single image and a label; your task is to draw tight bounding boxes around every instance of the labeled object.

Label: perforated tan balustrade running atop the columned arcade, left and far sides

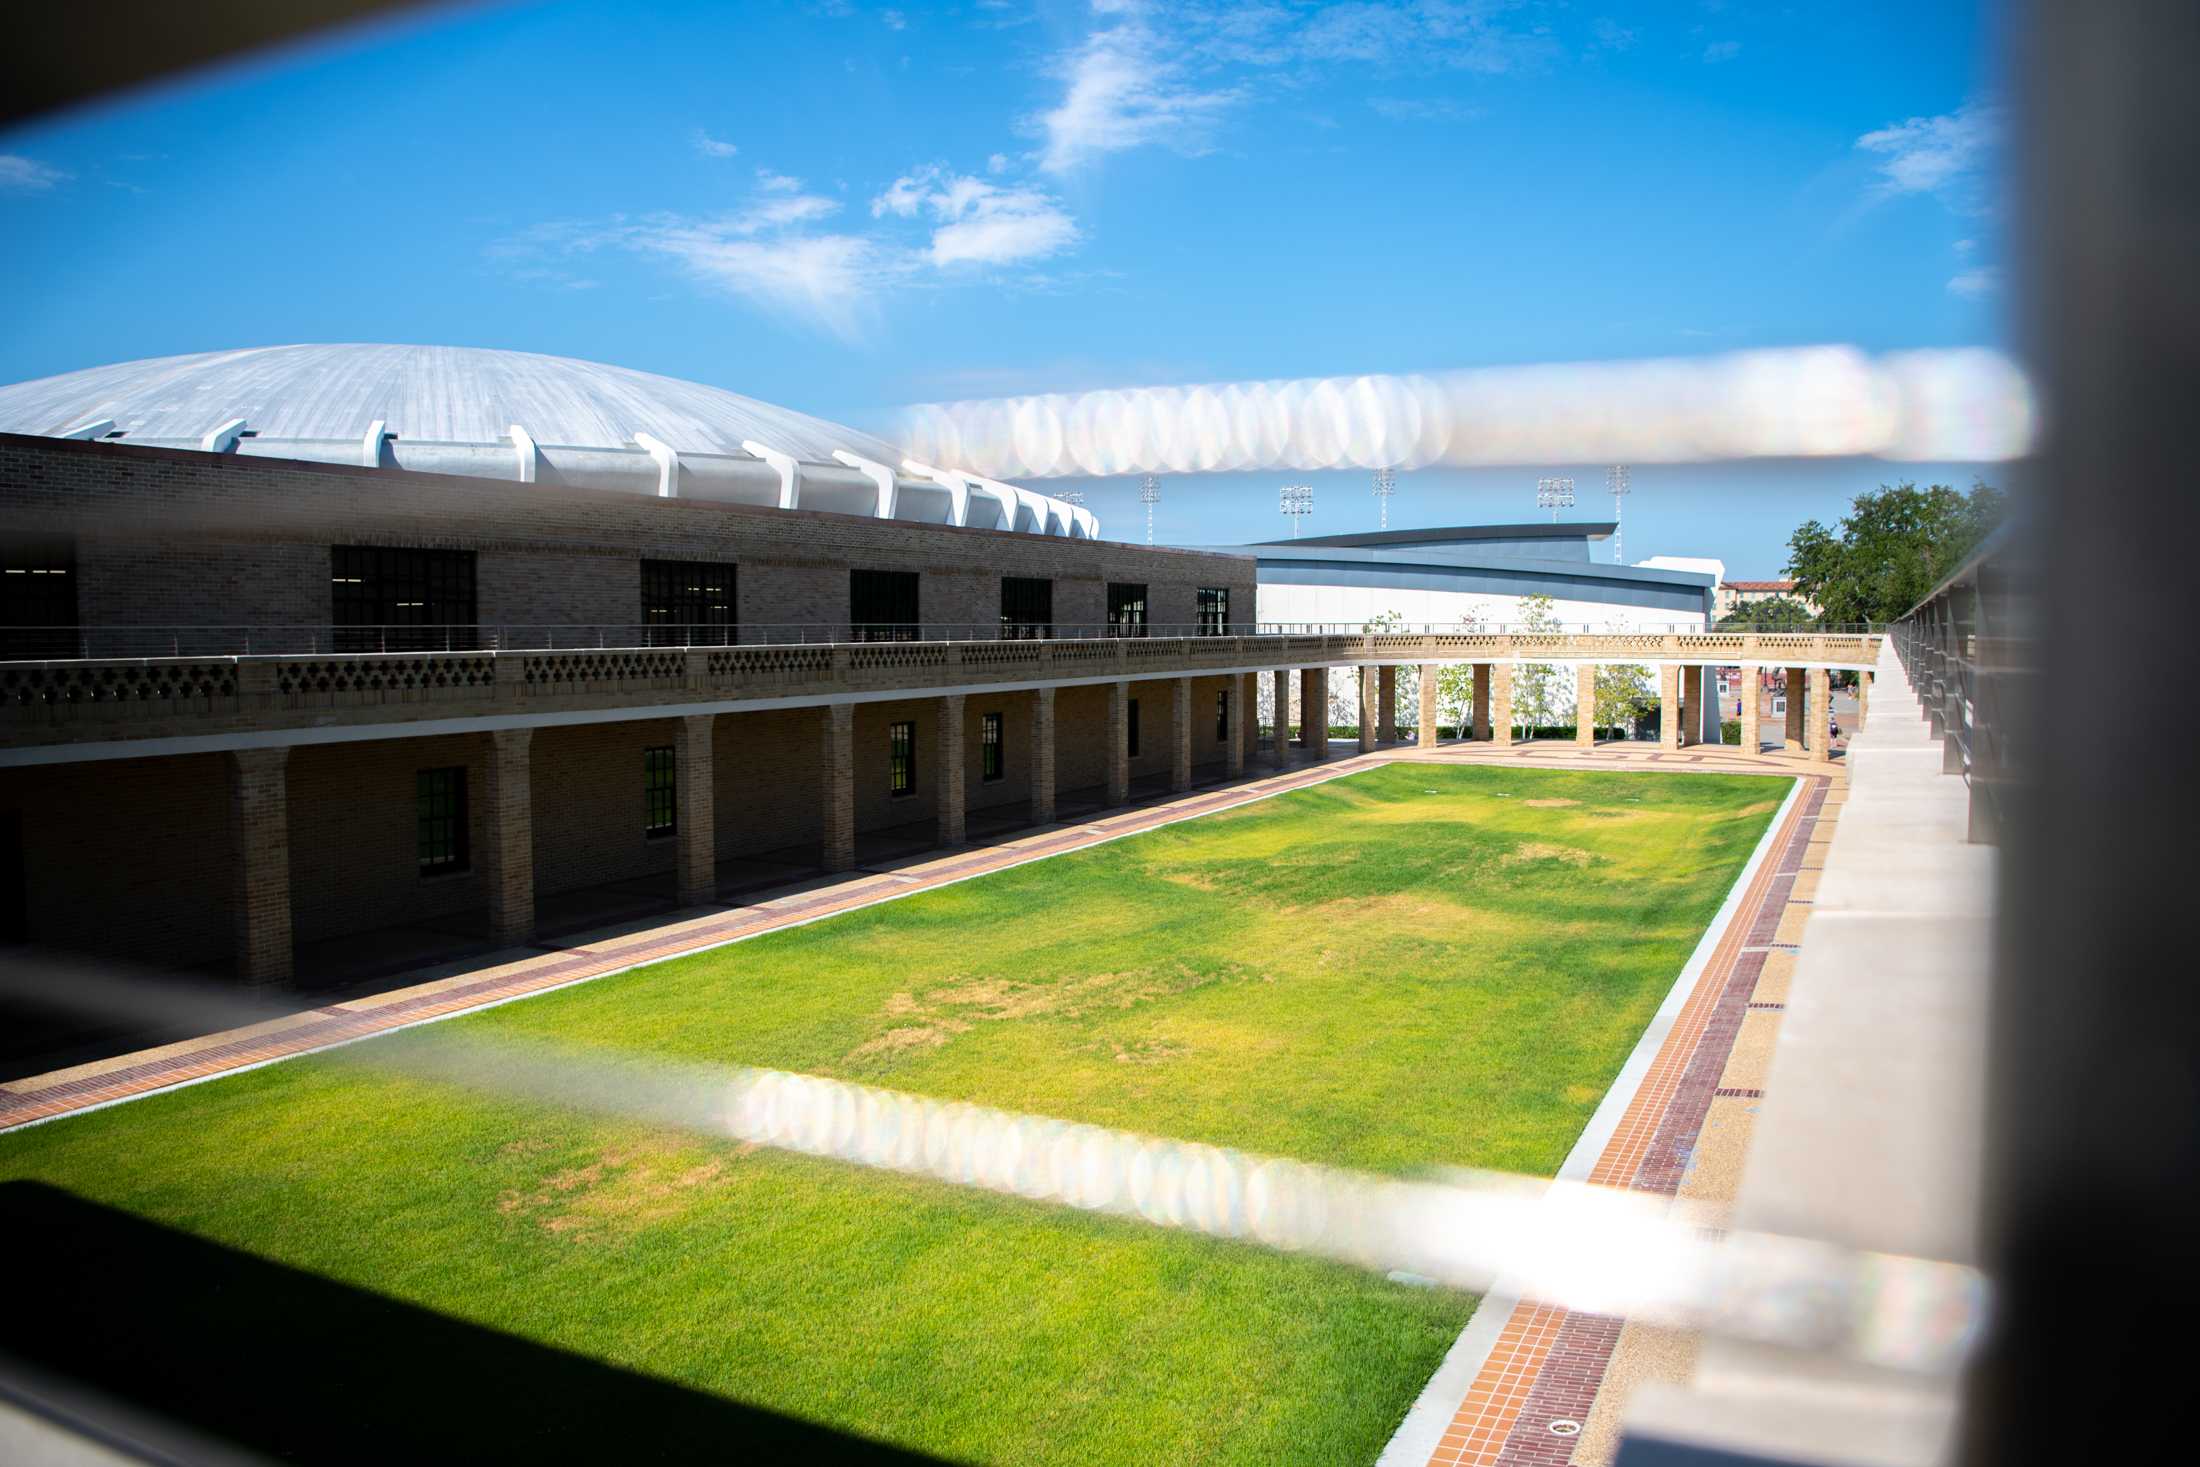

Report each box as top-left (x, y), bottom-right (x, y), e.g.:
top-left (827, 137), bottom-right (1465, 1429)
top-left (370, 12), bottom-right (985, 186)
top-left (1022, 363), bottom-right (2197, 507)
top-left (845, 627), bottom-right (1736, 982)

top-left (0, 631), bottom-right (1879, 748)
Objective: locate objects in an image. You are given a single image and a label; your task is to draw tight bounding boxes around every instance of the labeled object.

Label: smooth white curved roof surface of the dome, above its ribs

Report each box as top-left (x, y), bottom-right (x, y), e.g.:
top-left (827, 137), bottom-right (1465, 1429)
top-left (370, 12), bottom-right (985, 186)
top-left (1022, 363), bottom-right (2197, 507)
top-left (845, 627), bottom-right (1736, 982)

top-left (0, 345), bottom-right (902, 464)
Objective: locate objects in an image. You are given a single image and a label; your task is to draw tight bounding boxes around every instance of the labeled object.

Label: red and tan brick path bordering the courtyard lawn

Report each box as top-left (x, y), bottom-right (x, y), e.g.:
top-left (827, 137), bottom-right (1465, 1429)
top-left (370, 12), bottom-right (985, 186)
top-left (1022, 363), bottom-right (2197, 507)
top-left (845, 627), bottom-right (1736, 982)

top-left (0, 741), bottom-right (1833, 1467)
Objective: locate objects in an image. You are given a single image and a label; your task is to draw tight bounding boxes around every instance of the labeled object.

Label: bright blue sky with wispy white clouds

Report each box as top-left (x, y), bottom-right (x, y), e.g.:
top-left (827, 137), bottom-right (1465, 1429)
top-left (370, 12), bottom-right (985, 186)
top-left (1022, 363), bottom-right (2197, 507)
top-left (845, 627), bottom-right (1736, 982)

top-left (0, 0), bottom-right (2006, 576)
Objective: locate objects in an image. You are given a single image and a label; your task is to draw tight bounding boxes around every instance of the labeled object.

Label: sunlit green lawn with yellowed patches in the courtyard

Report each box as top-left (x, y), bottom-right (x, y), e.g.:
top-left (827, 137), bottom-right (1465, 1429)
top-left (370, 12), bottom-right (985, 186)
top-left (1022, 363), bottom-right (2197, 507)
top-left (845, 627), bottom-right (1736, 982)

top-left (0, 765), bottom-right (1784, 1463)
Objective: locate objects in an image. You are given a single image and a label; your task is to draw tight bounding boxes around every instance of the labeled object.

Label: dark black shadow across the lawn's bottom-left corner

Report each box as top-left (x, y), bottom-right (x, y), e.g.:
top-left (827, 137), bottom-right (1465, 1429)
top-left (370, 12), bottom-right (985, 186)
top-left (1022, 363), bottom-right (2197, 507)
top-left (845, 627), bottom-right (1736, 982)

top-left (0, 1183), bottom-right (937, 1465)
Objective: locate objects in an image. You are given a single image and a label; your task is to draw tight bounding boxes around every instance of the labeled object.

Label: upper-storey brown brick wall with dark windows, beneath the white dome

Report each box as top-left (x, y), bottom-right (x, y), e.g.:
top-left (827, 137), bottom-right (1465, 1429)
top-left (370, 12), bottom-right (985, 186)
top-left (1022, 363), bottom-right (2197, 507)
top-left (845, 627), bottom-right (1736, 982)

top-left (0, 433), bottom-right (1254, 642)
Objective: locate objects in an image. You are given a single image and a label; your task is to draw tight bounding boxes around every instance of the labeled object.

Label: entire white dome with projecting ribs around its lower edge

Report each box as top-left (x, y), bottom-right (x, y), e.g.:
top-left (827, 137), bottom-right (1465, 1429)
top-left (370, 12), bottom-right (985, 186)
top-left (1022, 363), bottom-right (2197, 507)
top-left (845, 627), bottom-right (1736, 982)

top-left (0, 345), bottom-right (1100, 539)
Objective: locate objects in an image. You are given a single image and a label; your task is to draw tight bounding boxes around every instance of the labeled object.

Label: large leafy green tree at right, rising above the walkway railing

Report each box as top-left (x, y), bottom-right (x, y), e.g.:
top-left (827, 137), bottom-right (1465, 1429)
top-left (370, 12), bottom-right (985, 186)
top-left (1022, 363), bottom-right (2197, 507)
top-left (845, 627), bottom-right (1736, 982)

top-left (1786, 482), bottom-right (2006, 622)
